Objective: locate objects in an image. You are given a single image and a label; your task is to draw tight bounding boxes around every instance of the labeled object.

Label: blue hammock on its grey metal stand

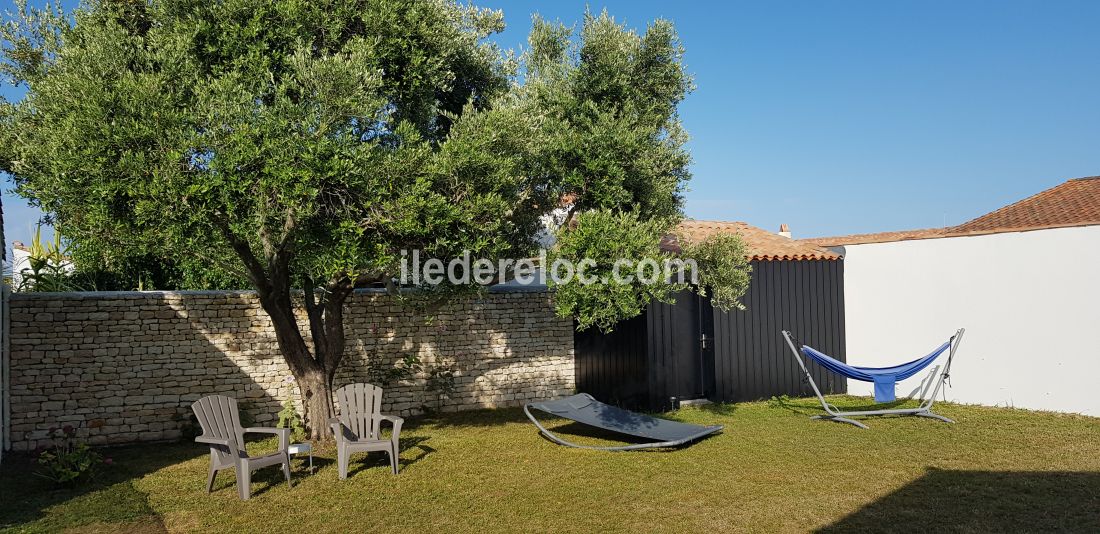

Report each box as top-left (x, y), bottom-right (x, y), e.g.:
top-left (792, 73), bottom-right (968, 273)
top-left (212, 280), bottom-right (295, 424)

top-left (783, 328), bottom-right (966, 428)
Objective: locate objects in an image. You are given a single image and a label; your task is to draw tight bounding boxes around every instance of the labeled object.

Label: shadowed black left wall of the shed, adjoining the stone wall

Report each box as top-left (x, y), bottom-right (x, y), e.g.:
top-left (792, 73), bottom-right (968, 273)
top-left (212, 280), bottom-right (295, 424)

top-left (573, 315), bottom-right (649, 407)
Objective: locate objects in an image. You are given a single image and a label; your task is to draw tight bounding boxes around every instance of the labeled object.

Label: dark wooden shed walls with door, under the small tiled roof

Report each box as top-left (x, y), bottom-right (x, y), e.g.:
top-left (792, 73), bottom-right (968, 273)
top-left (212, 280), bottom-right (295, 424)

top-left (574, 261), bottom-right (846, 410)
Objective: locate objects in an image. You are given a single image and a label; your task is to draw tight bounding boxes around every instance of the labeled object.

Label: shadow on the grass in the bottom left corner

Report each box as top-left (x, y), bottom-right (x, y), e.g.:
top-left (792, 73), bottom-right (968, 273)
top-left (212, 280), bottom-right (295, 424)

top-left (0, 444), bottom-right (206, 532)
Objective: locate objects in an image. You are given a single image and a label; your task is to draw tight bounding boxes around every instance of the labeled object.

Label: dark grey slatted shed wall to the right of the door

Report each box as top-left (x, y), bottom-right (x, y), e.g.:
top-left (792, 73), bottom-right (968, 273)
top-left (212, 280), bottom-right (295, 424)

top-left (714, 261), bottom-right (846, 402)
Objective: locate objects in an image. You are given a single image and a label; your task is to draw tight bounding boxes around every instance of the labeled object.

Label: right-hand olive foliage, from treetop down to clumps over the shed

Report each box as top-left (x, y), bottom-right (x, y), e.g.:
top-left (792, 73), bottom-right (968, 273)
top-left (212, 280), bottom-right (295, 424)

top-left (524, 11), bottom-right (748, 331)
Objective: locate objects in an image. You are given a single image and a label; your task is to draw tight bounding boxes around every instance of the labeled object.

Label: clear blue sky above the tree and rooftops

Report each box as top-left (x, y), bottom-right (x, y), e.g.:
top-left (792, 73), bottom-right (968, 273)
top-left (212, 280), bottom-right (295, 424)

top-left (0, 0), bottom-right (1100, 242)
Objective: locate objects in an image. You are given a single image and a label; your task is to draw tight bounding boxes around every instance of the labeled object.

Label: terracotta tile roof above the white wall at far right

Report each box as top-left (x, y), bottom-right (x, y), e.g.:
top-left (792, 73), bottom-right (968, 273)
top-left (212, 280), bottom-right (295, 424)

top-left (800, 176), bottom-right (1100, 247)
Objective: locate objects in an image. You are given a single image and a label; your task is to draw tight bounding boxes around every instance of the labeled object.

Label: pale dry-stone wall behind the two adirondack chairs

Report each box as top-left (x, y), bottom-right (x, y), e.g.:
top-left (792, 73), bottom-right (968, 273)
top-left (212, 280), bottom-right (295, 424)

top-left (10, 291), bottom-right (573, 450)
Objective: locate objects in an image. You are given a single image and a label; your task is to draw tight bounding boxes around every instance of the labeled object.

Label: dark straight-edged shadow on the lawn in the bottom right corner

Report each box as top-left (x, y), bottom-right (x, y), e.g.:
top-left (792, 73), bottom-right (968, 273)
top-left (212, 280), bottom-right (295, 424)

top-left (818, 469), bottom-right (1100, 533)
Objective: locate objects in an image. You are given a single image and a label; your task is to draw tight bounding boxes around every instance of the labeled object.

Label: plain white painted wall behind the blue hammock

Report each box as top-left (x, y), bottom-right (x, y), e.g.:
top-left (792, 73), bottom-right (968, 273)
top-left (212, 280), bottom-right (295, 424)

top-left (843, 226), bottom-right (1100, 416)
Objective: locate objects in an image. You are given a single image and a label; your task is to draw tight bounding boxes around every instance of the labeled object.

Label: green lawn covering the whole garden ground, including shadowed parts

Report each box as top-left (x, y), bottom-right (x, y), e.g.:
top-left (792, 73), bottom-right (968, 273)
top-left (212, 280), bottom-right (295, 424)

top-left (0, 397), bottom-right (1100, 532)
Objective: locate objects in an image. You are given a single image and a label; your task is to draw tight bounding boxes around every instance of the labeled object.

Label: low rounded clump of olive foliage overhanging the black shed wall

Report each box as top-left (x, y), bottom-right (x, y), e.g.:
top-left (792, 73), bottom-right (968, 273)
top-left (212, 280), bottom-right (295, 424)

top-left (547, 209), bottom-right (685, 331)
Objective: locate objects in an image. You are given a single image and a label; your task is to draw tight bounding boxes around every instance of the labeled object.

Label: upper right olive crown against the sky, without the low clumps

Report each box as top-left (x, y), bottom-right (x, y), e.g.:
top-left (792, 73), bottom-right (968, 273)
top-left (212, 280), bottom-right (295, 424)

top-left (524, 11), bottom-right (692, 219)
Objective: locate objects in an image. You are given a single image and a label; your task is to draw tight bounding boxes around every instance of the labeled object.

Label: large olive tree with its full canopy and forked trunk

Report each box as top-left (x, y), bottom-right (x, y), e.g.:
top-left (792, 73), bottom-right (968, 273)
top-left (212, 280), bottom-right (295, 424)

top-left (0, 0), bottom-right (744, 437)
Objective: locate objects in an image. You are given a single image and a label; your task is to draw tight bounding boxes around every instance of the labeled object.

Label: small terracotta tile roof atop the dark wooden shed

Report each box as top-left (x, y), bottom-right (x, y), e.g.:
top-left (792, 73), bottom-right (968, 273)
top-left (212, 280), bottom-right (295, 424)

top-left (661, 220), bottom-right (840, 261)
